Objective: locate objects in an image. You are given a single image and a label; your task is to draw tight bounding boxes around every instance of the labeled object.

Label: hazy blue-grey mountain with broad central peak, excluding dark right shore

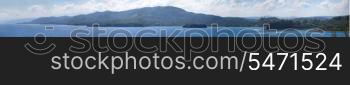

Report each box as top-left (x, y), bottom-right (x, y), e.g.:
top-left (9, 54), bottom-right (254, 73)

top-left (27, 6), bottom-right (254, 26)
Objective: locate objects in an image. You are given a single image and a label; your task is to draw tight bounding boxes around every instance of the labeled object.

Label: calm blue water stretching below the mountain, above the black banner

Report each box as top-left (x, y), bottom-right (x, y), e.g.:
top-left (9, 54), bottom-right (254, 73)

top-left (0, 24), bottom-right (345, 37)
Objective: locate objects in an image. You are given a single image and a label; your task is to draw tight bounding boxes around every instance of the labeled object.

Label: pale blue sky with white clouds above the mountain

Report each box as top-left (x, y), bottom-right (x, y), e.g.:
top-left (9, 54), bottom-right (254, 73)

top-left (0, 0), bottom-right (349, 22)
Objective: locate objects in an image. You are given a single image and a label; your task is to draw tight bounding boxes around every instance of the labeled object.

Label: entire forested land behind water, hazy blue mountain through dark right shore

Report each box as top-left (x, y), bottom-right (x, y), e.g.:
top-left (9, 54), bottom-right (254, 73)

top-left (27, 6), bottom-right (349, 31)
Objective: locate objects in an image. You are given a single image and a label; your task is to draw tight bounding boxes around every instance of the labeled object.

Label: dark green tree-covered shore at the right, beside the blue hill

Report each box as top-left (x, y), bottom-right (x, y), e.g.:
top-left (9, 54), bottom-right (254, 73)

top-left (257, 16), bottom-right (349, 31)
